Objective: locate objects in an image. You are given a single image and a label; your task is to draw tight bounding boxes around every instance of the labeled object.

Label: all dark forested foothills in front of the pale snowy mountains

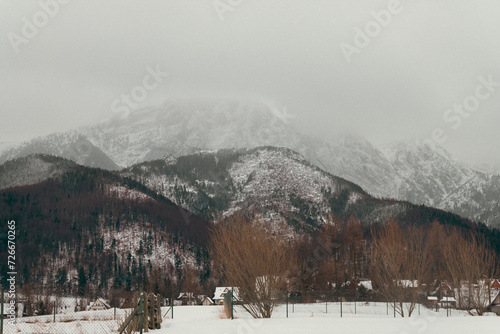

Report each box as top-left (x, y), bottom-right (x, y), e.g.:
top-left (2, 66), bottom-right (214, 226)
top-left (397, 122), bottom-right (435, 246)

top-left (0, 150), bottom-right (500, 296)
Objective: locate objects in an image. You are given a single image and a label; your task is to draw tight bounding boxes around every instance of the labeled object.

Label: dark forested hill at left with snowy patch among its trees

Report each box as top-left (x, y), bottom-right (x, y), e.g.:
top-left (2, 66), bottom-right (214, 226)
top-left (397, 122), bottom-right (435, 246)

top-left (0, 161), bottom-right (211, 296)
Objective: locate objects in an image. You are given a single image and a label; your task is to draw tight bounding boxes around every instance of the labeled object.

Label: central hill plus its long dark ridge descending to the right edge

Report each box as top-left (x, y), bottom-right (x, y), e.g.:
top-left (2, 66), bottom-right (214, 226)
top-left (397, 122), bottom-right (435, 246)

top-left (121, 147), bottom-right (500, 250)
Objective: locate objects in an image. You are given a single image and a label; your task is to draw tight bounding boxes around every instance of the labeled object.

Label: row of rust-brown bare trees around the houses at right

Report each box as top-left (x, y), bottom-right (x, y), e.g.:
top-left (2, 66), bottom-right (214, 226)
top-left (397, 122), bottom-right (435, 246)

top-left (289, 214), bottom-right (500, 312)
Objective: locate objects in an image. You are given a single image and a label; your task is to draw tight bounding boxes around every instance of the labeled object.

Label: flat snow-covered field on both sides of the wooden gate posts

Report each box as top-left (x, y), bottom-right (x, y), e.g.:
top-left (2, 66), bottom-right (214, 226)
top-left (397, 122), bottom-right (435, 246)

top-left (4, 302), bottom-right (500, 334)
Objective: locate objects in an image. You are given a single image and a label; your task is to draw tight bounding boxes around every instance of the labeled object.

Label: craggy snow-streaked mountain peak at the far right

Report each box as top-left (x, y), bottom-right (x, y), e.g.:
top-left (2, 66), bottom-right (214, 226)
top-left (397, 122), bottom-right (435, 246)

top-left (391, 143), bottom-right (500, 227)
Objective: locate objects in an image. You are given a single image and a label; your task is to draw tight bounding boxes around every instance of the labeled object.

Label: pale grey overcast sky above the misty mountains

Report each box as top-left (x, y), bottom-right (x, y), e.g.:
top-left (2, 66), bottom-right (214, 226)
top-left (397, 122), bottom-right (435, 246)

top-left (0, 0), bottom-right (500, 165)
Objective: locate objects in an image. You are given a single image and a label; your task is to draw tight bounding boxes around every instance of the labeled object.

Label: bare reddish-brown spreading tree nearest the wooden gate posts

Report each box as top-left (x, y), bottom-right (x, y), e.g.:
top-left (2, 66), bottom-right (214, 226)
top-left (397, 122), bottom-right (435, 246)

top-left (211, 216), bottom-right (295, 318)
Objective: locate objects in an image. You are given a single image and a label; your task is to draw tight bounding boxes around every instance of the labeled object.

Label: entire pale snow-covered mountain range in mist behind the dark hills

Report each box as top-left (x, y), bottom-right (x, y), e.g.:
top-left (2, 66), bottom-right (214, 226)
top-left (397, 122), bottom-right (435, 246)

top-left (0, 99), bottom-right (500, 227)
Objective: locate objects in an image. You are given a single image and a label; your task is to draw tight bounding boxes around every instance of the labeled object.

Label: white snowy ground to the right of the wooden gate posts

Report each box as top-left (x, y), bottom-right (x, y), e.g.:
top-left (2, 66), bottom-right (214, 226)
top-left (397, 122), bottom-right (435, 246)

top-left (161, 303), bottom-right (500, 334)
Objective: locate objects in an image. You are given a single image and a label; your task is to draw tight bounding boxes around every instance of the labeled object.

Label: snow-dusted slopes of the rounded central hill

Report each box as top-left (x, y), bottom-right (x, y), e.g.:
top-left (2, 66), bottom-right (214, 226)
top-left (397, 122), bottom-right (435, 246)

top-left (123, 147), bottom-right (367, 228)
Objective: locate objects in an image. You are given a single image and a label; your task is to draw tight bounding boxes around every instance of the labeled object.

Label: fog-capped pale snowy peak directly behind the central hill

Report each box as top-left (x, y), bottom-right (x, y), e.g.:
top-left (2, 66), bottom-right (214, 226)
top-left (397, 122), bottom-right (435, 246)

top-left (80, 99), bottom-right (300, 167)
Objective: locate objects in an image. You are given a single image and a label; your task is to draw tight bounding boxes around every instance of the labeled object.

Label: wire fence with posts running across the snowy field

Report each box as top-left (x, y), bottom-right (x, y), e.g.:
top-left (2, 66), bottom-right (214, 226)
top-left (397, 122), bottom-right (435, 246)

top-left (0, 290), bottom-right (465, 334)
